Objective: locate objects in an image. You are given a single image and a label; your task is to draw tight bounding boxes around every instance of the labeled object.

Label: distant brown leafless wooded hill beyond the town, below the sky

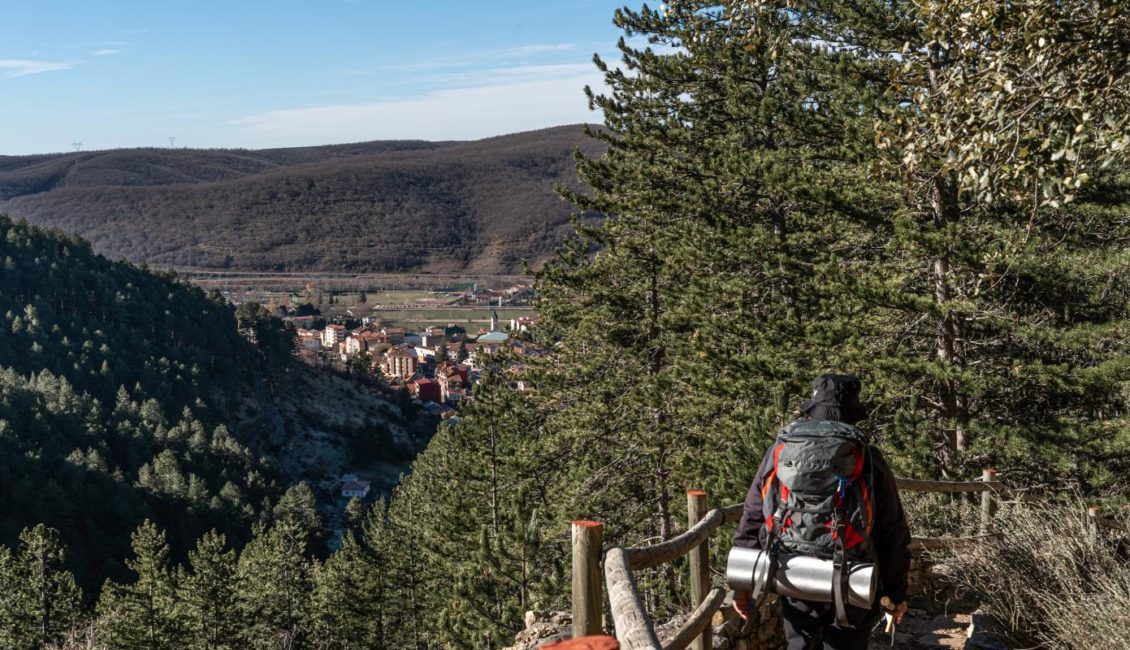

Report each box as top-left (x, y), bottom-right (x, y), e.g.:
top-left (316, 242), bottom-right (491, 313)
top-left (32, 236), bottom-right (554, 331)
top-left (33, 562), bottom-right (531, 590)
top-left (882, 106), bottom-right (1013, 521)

top-left (0, 124), bottom-right (599, 272)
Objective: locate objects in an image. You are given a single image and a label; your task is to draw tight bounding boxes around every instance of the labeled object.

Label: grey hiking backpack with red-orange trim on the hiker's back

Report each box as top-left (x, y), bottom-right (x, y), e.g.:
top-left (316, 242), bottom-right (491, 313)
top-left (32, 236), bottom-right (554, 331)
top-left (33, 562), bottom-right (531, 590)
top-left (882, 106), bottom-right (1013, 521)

top-left (762, 419), bottom-right (876, 625)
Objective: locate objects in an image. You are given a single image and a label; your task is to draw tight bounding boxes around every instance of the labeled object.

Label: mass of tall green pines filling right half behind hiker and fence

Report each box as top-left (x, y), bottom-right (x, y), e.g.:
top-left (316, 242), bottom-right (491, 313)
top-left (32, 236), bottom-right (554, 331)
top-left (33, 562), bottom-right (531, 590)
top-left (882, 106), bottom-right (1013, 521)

top-left (381, 0), bottom-right (1130, 647)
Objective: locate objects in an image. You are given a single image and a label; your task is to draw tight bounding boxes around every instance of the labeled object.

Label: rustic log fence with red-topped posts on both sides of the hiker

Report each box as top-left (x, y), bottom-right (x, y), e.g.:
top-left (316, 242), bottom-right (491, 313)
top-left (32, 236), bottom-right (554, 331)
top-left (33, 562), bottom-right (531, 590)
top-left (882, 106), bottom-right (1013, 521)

top-left (573, 469), bottom-right (1015, 650)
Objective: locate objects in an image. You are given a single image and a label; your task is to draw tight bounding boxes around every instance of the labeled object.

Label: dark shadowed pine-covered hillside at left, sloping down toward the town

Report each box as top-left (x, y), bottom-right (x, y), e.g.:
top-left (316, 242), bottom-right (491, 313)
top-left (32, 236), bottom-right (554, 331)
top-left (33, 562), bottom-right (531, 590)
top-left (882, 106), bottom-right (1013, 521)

top-left (0, 216), bottom-right (420, 596)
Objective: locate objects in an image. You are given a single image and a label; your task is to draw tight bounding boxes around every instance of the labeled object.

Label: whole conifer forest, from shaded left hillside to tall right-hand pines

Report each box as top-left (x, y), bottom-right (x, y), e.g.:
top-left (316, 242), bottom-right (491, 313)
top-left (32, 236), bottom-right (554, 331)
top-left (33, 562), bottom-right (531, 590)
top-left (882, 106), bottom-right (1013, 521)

top-left (0, 0), bottom-right (1130, 650)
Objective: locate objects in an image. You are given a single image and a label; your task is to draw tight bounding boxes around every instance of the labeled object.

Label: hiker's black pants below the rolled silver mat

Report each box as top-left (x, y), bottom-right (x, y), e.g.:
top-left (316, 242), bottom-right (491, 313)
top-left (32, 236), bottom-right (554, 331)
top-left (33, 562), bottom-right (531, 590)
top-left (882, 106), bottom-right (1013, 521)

top-left (780, 598), bottom-right (881, 650)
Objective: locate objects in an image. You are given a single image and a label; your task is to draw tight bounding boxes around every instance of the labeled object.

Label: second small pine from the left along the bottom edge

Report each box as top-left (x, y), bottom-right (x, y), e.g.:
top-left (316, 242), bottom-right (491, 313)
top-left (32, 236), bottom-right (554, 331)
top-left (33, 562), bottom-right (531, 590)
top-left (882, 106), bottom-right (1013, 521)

top-left (97, 520), bottom-right (181, 650)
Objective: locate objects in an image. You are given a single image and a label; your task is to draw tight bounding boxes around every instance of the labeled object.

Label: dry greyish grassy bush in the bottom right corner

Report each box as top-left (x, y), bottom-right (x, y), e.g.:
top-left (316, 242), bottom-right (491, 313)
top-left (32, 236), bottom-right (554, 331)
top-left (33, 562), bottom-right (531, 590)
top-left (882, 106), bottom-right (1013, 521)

top-left (948, 499), bottom-right (1130, 650)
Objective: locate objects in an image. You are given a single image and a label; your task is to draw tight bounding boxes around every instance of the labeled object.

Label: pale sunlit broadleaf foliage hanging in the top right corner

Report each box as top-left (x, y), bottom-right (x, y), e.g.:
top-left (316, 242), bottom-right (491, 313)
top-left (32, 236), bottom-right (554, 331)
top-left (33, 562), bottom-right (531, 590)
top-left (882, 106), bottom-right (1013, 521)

top-left (878, 0), bottom-right (1130, 205)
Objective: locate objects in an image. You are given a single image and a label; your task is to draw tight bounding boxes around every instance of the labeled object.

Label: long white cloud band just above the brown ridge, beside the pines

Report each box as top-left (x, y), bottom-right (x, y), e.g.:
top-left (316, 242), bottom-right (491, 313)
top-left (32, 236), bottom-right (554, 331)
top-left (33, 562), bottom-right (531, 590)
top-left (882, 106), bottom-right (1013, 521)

top-left (229, 67), bottom-right (601, 146)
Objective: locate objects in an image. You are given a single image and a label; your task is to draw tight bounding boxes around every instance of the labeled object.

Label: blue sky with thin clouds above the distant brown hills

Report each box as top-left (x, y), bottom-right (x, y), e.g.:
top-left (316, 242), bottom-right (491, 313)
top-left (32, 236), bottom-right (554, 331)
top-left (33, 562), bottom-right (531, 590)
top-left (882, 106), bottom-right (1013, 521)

top-left (0, 0), bottom-right (625, 155)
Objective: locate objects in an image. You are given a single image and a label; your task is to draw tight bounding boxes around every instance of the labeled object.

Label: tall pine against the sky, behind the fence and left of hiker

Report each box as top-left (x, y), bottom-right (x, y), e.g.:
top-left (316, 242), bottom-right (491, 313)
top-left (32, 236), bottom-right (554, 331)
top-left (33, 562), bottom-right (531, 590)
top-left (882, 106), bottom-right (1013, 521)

top-left (538, 1), bottom-right (884, 593)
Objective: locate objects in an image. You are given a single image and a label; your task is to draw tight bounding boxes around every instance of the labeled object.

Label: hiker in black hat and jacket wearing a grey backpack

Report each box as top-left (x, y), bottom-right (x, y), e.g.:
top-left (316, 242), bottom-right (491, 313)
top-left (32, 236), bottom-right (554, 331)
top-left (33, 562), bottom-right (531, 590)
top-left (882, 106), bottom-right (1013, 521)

top-left (733, 374), bottom-right (911, 650)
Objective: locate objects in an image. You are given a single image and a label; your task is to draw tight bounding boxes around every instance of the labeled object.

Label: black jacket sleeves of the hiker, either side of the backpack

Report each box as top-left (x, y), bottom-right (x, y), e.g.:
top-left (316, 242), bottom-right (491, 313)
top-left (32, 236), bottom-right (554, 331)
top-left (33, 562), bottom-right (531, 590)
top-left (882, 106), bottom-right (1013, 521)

top-left (733, 427), bottom-right (911, 603)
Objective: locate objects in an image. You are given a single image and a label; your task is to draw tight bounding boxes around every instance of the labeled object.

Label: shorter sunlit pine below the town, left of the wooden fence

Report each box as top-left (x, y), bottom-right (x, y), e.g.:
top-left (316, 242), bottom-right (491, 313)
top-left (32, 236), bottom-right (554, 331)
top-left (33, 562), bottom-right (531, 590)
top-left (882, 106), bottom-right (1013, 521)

top-left (393, 361), bottom-right (560, 648)
